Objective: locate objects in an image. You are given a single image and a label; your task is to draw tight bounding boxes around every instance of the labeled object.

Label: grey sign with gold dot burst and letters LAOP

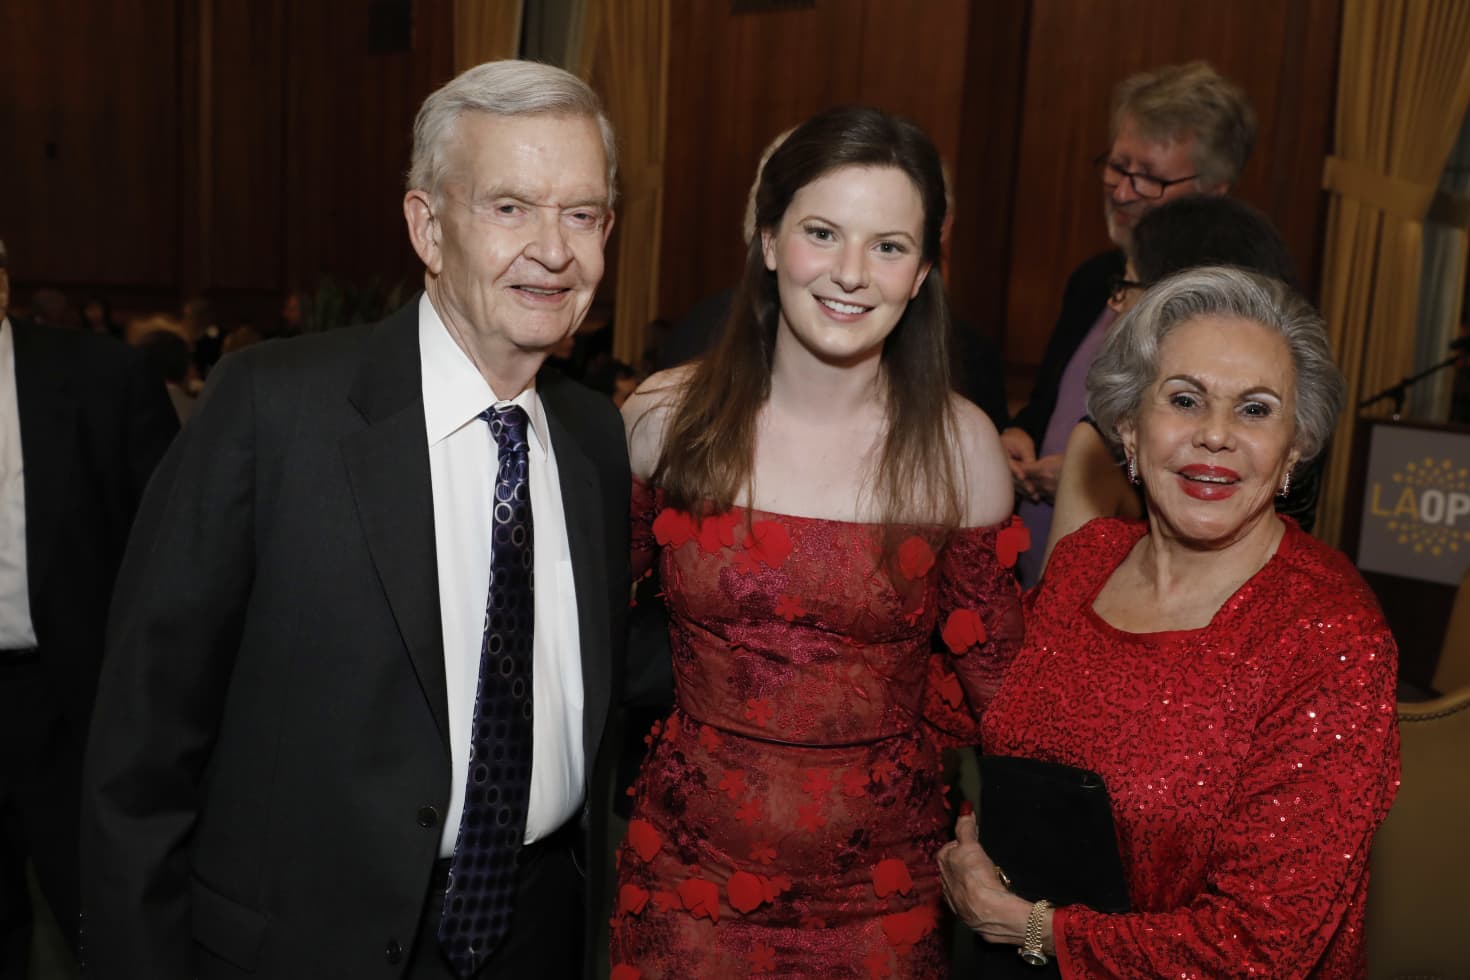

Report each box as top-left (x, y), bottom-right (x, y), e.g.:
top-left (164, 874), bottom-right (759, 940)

top-left (1358, 426), bottom-right (1470, 585)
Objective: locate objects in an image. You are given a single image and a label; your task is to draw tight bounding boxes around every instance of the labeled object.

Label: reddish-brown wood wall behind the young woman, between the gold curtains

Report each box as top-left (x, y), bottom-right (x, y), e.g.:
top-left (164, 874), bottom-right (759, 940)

top-left (662, 0), bottom-right (1341, 382)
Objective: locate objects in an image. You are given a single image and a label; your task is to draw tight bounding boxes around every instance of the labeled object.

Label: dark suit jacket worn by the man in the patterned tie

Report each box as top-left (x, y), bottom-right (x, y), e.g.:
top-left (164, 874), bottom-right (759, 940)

top-left (82, 301), bottom-right (629, 980)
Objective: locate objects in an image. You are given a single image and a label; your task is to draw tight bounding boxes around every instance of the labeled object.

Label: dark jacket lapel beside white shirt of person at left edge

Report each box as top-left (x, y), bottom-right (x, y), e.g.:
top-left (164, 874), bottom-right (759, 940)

top-left (10, 317), bottom-right (79, 602)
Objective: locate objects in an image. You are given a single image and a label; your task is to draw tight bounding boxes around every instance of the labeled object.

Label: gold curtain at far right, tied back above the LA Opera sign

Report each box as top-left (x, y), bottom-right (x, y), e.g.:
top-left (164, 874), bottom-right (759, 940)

top-left (1317, 0), bottom-right (1470, 544)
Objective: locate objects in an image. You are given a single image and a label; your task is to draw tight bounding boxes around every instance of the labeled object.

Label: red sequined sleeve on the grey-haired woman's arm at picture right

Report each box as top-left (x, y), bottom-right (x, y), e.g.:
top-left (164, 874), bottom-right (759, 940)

top-left (1053, 614), bottom-right (1398, 977)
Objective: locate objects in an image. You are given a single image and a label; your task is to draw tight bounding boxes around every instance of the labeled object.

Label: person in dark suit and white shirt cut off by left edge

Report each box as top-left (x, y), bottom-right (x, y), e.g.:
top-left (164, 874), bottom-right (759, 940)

top-left (0, 235), bottom-right (178, 979)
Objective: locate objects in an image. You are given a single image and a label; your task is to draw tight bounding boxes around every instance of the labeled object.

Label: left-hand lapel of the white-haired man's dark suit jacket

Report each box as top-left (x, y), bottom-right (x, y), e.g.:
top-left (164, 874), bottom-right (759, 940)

top-left (343, 307), bottom-right (448, 743)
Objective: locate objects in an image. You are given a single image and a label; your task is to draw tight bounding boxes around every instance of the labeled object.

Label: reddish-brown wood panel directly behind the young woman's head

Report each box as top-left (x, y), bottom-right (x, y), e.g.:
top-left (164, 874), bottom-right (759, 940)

top-left (661, 0), bottom-right (970, 319)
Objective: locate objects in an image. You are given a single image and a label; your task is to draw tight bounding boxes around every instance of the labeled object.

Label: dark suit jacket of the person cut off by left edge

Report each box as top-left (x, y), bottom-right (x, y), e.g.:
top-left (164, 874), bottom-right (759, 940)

top-left (10, 317), bottom-right (179, 731)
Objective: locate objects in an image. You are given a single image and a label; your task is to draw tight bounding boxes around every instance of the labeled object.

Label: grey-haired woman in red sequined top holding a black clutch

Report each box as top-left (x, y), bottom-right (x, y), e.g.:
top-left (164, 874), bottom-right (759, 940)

top-left (939, 269), bottom-right (1398, 979)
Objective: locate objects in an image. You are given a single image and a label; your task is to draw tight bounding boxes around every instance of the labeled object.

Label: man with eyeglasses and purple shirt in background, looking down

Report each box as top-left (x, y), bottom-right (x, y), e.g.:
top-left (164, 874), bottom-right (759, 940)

top-left (1001, 62), bottom-right (1255, 588)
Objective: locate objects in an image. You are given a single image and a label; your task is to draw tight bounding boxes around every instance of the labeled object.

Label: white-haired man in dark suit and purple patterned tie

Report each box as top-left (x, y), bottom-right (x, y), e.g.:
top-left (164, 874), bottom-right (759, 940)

top-left (82, 62), bottom-right (629, 980)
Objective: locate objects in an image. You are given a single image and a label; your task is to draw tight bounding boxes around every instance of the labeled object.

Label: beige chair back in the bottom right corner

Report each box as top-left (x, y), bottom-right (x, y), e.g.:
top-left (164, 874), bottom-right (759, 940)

top-left (1367, 686), bottom-right (1470, 980)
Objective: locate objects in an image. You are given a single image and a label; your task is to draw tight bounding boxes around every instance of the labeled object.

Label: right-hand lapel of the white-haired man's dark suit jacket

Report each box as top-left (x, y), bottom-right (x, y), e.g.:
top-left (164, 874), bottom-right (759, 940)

top-left (538, 382), bottom-right (612, 779)
